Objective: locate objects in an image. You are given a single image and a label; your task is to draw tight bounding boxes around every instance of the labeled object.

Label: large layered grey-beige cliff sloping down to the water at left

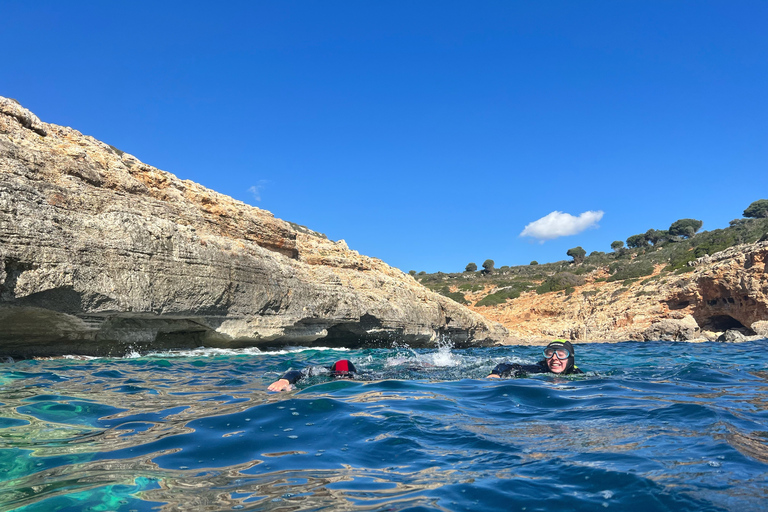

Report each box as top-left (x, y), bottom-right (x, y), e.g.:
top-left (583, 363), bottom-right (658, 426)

top-left (0, 97), bottom-right (507, 357)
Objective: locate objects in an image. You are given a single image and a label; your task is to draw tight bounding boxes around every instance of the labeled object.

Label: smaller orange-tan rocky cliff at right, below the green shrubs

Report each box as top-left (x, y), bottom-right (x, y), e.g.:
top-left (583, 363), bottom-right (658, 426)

top-left (470, 242), bottom-right (768, 342)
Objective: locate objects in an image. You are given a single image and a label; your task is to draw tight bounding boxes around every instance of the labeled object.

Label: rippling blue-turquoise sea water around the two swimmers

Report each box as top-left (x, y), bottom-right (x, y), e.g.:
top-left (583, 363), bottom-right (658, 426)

top-left (0, 340), bottom-right (768, 512)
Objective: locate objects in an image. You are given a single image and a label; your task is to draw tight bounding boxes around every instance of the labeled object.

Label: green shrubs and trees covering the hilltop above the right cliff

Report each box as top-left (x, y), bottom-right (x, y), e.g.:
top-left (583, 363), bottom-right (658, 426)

top-left (410, 199), bottom-right (768, 306)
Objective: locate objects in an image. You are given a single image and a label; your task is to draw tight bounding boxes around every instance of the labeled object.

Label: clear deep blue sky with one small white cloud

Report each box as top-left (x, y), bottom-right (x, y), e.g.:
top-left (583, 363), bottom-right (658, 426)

top-left (0, 0), bottom-right (768, 272)
